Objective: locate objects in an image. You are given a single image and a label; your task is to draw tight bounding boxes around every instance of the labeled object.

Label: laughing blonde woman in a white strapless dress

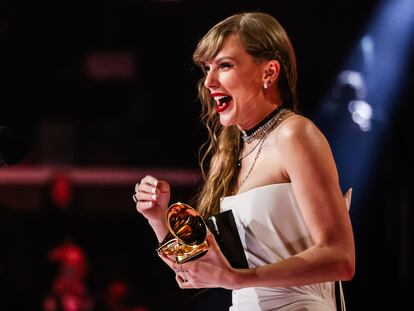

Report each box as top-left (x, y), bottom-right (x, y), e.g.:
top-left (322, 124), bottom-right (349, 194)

top-left (134, 13), bottom-right (355, 311)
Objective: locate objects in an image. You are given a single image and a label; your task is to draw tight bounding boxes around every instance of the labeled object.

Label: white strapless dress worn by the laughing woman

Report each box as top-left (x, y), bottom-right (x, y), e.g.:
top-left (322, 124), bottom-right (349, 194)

top-left (220, 183), bottom-right (336, 311)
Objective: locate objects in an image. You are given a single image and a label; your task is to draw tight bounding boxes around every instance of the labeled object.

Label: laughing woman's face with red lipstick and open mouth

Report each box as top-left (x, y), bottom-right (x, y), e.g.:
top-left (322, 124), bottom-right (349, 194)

top-left (204, 35), bottom-right (265, 129)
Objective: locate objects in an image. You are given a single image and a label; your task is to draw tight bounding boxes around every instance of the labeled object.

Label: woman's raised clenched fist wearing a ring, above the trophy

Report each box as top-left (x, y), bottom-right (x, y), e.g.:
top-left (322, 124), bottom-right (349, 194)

top-left (134, 175), bottom-right (171, 222)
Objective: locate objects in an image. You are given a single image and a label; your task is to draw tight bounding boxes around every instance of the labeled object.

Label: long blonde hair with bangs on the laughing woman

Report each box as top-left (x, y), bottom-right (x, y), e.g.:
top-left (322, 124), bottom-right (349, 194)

top-left (193, 13), bottom-right (297, 217)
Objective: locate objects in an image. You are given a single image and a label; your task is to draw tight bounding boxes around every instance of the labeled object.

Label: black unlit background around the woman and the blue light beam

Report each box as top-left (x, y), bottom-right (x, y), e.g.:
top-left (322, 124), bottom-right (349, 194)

top-left (0, 0), bottom-right (414, 310)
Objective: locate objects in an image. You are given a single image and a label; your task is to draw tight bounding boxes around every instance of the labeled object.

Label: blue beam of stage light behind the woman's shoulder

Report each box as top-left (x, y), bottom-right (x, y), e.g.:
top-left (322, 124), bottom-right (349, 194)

top-left (314, 0), bottom-right (414, 213)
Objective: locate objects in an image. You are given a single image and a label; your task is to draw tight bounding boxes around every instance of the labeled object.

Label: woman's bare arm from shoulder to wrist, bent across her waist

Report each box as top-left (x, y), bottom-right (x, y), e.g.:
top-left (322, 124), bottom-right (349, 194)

top-left (232, 117), bottom-right (355, 288)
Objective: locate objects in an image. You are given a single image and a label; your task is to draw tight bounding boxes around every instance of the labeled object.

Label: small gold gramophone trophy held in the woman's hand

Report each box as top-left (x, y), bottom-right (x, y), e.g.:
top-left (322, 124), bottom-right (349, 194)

top-left (157, 202), bottom-right (208, 264)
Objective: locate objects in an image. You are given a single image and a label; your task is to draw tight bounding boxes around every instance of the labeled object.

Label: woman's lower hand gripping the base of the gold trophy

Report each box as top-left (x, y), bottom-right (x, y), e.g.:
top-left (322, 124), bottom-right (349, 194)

top-left (161, 232), bottom-right (241, 289)
